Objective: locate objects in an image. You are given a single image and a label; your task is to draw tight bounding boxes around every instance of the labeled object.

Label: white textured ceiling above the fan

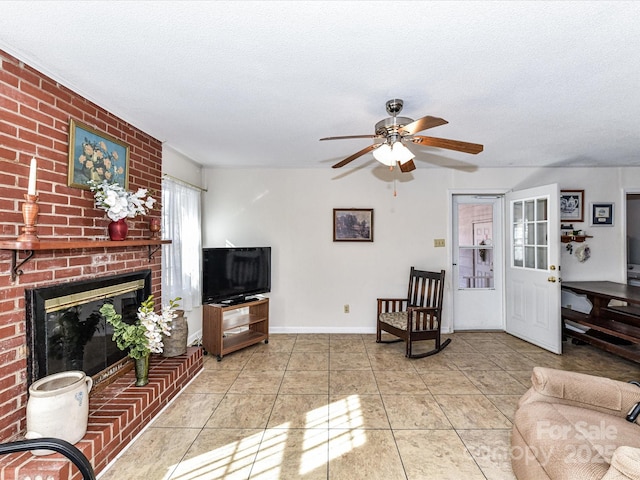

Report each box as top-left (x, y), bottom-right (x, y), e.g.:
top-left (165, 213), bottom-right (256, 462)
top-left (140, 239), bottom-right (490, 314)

top-left (0, 1), bottom-right (640, 169)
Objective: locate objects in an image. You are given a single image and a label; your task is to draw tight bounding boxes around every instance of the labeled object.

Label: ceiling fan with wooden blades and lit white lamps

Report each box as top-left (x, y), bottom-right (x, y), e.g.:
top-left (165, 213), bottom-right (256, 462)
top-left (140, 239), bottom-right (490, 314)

top-left (320, 99), bottom-right (483, 172)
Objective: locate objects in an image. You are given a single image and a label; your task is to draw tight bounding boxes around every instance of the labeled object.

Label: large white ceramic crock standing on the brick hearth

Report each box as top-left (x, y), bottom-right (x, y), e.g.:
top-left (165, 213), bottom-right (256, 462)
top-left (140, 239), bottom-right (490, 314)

top-left (25, 370), bottom-right (93, 455)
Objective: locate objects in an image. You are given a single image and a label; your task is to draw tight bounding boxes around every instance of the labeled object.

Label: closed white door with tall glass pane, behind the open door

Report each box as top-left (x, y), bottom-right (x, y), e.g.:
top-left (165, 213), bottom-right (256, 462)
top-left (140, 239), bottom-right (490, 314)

top-left (453, 195), bottom-right (505, 331)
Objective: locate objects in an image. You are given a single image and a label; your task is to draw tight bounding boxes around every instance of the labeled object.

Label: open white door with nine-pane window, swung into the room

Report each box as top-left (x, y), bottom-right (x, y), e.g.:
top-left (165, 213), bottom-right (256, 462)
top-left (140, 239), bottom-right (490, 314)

top-left (505, 184), bottom-right (562, 354)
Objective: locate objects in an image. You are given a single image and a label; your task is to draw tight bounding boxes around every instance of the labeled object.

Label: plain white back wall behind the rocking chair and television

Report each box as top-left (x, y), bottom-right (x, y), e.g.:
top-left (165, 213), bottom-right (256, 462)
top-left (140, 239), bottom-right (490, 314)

top-left (203, 167), bottom-right (640, 332)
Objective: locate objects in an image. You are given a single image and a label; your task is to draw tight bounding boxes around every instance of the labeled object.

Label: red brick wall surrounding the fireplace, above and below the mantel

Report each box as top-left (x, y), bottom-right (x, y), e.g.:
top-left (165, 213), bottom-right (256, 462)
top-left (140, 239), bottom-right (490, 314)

top-left (0, 50), bottom-right (162, 442)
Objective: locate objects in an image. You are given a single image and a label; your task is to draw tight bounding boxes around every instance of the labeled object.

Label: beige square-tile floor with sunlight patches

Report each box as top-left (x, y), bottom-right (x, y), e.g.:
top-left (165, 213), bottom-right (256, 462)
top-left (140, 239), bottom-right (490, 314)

top-left (100, 332), bottom-right (640, 480)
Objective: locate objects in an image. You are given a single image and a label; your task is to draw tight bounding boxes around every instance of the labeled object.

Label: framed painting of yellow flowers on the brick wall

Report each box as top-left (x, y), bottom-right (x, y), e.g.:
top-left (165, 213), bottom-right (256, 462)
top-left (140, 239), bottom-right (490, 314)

top-left (67, 119), bottom-right (129, 190)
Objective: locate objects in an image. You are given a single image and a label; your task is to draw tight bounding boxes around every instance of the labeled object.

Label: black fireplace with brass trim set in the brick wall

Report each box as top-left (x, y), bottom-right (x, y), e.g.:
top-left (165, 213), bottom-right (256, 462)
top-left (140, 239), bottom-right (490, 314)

top-left (25, 270), bottom-right (151, 385)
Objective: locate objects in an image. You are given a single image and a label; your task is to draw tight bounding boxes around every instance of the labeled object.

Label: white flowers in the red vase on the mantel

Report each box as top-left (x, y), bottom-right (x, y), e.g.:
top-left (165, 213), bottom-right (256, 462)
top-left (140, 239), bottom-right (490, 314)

top-left (87, 180), bottom-right (156, 222)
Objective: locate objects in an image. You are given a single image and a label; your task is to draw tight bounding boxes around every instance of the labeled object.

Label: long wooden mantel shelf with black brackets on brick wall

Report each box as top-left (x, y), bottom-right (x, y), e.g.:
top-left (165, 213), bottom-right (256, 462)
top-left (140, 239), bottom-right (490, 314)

top-left (0, 239), bottom-right (171, 282)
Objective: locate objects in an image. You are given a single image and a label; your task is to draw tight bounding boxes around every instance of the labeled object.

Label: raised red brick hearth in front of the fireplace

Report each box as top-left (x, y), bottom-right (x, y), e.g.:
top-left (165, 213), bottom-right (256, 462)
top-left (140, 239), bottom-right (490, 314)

top-left (0, 347), bottom-right (203, 480)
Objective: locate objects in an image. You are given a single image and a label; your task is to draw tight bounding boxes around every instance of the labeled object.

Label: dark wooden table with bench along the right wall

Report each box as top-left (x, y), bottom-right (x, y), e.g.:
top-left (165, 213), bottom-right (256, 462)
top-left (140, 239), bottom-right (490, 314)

top-left (562, 282), bottom-right (640, 363)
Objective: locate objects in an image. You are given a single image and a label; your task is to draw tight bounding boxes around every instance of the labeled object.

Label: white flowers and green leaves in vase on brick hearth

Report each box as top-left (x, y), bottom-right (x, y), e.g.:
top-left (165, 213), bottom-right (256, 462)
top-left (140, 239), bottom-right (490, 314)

top-left (100, 295), bottom-right (181, 360)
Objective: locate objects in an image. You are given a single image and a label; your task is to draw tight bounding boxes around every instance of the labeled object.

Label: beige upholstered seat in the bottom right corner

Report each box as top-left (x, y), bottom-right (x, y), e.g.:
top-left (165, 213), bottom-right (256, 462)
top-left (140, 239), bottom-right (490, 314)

top-left (510, 367), bottom-right (640, 480)
